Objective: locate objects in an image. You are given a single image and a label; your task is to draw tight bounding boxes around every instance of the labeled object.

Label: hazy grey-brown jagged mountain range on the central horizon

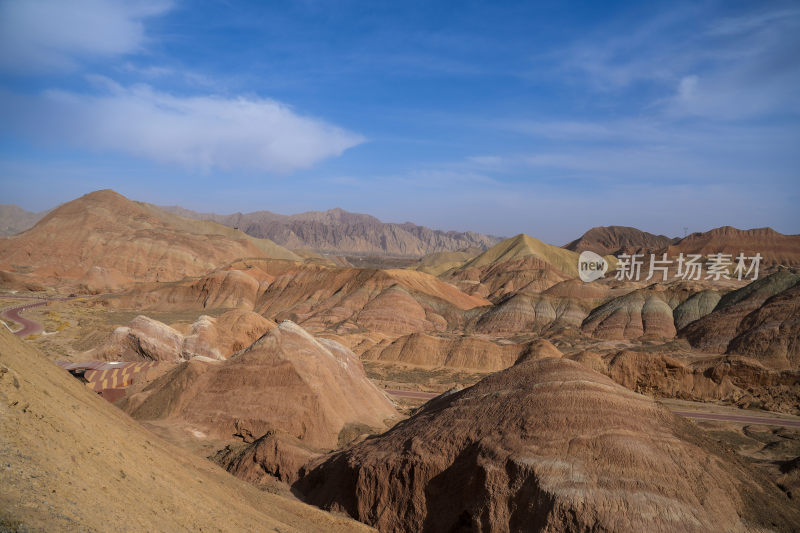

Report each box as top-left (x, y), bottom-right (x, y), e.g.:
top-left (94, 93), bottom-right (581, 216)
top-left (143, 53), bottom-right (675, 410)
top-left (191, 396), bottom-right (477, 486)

top-left (161, 206), bottom-right (501, 257)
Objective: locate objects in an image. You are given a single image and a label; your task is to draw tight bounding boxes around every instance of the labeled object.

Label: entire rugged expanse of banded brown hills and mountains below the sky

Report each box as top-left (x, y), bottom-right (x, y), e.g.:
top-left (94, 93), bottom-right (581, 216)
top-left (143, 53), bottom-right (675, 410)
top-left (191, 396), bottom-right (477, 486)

top-left (0, 190), bottom-right (800, 532)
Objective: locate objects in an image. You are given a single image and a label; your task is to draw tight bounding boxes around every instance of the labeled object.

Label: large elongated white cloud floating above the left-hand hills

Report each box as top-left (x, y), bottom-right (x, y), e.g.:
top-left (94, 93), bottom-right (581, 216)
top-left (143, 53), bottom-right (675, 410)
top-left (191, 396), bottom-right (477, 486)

top-left (0, 78), bottom-right (364, 172)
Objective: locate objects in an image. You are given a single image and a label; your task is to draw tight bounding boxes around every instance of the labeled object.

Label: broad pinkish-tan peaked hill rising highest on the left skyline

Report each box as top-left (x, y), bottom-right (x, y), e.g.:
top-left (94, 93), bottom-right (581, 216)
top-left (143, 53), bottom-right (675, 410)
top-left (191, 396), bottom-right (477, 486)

top-left (0, 190), bottom-right (300, 282)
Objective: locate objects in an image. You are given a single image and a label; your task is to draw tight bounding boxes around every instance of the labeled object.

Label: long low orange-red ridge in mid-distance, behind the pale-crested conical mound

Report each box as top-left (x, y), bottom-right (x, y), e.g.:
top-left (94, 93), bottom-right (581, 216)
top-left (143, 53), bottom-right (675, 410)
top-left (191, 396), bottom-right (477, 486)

top-left (110, 261), bottom-right (491, 336)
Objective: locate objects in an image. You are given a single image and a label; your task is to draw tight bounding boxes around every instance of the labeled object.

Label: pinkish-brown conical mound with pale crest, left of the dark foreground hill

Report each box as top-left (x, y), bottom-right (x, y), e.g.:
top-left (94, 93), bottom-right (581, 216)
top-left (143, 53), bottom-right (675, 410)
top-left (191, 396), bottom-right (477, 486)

top-left (122, 322), bottom-right (397, 449)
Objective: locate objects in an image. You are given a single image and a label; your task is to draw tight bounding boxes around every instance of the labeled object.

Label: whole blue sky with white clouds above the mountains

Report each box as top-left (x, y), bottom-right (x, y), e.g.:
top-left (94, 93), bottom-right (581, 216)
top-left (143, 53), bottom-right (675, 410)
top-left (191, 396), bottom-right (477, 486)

top-left (0, 0), bottom-right (800, 245)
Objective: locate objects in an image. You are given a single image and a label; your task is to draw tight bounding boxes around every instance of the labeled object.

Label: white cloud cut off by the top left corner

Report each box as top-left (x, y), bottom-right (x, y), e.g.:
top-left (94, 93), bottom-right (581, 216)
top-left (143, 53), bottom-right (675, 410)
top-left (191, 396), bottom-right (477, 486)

top-left (0, 0), bottom-right (171, 72)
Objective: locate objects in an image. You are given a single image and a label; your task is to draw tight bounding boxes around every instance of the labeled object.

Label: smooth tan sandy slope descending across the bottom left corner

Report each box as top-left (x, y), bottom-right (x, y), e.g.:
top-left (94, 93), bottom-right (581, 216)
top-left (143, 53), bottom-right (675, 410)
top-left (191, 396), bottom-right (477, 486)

top-left (0, 328), bottom-right (368, 532)
